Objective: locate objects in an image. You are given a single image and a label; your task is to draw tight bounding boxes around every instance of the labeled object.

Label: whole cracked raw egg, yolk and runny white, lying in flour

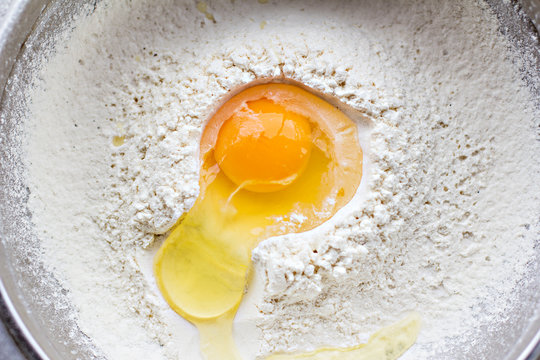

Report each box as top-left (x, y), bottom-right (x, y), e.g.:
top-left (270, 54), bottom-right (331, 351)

top-left (154, 84), bottom-right (418, 360)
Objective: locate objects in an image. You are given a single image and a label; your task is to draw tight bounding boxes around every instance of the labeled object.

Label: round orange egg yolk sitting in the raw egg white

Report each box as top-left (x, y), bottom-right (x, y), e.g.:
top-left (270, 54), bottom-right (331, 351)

top-left (214, 99), bottom-right (311, 192)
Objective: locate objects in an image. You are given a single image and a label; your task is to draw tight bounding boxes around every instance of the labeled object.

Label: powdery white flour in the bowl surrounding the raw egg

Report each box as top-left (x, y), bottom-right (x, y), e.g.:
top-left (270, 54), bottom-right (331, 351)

top-left (26, 0), bottom-right (540, 360)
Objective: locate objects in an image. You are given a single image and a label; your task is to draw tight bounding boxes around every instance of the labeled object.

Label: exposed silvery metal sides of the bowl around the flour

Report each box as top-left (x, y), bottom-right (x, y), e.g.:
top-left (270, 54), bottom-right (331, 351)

top-left (0, 0), bottom-right (540, 360)
